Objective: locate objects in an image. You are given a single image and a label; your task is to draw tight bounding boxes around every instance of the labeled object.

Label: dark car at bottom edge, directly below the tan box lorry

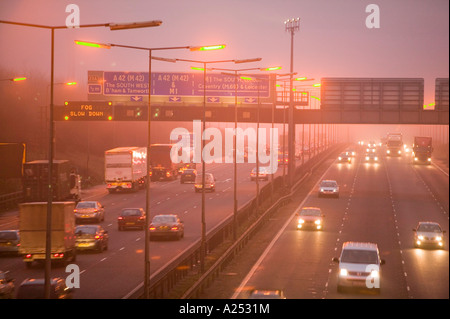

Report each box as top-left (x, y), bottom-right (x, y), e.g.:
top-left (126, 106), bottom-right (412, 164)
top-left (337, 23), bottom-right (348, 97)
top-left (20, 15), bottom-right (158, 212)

top-left (16, 277), bottom-right (75, 299)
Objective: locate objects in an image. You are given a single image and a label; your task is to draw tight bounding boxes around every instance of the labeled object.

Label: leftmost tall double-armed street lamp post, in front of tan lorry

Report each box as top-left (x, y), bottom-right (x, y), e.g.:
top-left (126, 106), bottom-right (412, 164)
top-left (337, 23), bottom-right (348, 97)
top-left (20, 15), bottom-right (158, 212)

top-left (0, 20), bottom-right (162, 299)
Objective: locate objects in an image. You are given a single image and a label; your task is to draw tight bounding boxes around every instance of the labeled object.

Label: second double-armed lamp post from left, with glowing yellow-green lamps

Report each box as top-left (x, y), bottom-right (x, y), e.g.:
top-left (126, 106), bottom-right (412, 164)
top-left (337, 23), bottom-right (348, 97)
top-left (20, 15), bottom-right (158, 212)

top-left (75, 40), bottom-right (225, 299)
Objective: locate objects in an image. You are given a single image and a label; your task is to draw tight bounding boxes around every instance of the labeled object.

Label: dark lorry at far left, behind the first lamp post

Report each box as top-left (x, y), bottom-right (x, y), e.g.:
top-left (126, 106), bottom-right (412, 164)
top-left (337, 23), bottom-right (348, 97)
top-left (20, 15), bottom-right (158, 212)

top-left (22, 160), bottom-right (81, 202)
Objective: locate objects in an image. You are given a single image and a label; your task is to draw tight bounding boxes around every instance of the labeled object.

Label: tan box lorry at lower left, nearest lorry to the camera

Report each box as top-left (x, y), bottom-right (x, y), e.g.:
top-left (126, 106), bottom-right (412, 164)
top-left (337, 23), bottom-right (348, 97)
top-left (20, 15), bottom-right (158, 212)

top-left (19, 202), bottom-right (76, 267)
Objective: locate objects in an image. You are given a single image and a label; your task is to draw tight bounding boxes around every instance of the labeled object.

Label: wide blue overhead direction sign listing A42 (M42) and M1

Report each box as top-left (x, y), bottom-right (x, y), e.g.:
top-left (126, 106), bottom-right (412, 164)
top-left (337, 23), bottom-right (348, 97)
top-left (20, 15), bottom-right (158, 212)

top-left (88, 71), bottom-right (270, 98)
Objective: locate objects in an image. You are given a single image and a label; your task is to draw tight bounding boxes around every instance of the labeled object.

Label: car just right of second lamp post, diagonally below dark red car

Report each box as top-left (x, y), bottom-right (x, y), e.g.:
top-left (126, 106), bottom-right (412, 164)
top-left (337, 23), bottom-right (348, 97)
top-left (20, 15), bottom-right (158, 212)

top-left (149, 214), bottom-right (184, 240)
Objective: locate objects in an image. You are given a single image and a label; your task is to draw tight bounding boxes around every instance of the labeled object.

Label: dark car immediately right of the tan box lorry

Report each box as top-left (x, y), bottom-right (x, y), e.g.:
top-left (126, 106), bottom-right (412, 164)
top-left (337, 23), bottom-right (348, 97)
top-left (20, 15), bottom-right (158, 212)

top-left (75, 225), bottom-right (109, 252)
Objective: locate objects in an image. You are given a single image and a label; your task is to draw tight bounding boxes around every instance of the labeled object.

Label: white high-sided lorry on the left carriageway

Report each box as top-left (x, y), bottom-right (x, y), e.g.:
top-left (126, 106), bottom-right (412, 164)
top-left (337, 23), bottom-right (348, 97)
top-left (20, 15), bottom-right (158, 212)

top-left (105, 146), bottom-right (147, 193)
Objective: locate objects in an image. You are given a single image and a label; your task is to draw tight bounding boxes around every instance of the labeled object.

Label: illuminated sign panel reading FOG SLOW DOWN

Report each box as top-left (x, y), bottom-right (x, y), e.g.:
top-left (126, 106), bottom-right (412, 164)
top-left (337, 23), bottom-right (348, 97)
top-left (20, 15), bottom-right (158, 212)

top-left (60, 101), bottom-right (113, 121)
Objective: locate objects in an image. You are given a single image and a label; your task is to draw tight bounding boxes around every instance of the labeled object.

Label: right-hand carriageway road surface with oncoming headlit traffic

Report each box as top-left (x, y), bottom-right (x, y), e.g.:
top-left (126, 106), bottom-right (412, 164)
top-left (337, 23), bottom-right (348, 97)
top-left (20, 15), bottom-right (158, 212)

top-left (232, 150), bottom-right (449, 299)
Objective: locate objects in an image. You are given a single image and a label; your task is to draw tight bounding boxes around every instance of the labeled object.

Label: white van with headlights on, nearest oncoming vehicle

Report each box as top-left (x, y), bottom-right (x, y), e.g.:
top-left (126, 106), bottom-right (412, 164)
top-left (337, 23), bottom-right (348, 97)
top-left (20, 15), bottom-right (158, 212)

top-left (333, 241), bottom-right (385, 293)
